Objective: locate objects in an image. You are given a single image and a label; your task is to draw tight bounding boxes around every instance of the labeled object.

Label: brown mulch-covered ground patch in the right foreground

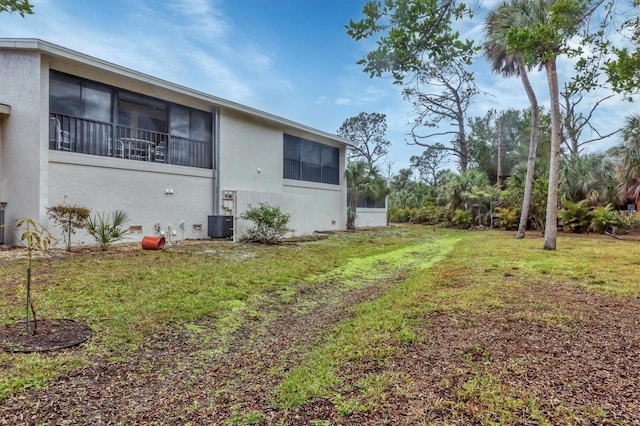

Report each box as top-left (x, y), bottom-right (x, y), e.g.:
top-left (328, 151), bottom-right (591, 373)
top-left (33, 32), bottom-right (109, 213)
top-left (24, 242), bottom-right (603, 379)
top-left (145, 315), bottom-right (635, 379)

top-left (290, 286), bottom-right (640, 425)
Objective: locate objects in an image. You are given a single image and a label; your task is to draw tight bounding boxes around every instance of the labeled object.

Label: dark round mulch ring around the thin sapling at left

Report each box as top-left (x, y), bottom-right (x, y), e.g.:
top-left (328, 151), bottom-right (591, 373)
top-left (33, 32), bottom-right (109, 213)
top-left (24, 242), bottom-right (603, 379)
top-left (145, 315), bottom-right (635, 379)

top-left (0, 319), bottom-right (92, 352)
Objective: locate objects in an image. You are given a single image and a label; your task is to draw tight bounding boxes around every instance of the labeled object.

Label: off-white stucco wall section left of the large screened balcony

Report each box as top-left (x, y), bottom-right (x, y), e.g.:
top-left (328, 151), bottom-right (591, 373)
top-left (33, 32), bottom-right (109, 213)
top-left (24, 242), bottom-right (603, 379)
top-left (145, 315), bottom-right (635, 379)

top-left (0, 51), bottom-right (48, 245)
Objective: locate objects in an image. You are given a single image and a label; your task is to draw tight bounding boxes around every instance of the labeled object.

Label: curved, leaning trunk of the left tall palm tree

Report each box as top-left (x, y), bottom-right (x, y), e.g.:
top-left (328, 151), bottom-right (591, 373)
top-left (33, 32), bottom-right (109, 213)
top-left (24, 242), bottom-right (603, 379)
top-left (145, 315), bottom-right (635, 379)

top-left (516, 54), bottom-right (540, 238)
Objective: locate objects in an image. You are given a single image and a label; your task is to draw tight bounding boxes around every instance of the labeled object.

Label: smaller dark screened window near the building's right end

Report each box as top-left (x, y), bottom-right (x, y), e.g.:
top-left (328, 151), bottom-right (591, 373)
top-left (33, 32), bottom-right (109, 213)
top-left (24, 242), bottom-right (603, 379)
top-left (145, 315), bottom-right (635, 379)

top-left (283, 134), bottom-right (340, 185)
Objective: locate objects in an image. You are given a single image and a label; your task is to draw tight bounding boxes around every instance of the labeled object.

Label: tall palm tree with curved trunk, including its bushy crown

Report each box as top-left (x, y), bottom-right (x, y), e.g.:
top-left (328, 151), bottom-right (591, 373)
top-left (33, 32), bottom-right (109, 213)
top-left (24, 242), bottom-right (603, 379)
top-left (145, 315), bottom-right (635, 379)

top-left (484, 1), bottom-right (540, 238)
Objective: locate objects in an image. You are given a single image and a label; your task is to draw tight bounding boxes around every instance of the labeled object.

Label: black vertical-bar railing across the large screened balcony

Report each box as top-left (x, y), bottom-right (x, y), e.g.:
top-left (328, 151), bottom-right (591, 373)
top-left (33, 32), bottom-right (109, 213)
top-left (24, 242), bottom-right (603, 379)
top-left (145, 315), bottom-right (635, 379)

top-left (49, 114), bottom-right (213, 169)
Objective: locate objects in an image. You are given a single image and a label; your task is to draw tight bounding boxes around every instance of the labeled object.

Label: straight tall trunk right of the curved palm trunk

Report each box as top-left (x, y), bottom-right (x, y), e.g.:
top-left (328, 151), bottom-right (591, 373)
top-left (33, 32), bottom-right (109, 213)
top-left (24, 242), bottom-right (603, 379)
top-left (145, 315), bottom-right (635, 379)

top-left (543, 58), bottom-right (562, 250)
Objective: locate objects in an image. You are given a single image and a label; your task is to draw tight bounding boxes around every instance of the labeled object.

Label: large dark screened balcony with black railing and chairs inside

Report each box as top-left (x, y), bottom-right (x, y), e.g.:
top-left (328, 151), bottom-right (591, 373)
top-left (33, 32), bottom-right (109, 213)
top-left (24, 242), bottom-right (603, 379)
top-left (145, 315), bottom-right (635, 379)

top-left (49, 70), bottom-right (213, 169)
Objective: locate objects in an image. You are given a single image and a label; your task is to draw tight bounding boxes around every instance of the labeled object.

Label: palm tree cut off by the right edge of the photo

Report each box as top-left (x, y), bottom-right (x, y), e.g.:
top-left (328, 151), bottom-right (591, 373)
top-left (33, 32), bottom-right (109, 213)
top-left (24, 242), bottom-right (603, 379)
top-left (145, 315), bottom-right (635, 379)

top-left (609, 113), bottom-right (640, 204)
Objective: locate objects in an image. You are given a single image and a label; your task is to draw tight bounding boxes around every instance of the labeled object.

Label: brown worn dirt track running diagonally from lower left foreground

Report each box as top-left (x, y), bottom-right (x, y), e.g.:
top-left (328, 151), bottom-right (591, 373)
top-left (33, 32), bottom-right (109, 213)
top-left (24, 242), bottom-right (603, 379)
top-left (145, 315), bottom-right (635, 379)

top-left (0, 271), bottom-right (402, 425)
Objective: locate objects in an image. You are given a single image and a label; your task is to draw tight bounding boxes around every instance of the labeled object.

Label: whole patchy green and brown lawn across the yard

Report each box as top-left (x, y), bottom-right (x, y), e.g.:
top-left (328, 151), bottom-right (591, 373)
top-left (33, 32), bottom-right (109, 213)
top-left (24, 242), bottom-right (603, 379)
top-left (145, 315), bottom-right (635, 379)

top-left (0, 226), bottom-right (640, 425)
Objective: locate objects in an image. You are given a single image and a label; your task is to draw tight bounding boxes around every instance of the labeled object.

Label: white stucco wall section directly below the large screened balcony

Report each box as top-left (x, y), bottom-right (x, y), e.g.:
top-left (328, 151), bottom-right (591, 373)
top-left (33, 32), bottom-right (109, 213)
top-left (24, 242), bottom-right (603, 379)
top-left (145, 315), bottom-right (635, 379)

top-left (49, 152), bottom-right (213, 243)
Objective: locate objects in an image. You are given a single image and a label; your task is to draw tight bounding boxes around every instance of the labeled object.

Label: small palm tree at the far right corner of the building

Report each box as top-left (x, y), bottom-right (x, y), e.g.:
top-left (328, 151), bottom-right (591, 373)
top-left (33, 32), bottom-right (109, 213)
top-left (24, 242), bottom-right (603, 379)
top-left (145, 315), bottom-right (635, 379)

top-left (345, 161), bottom-right (388, 231)
